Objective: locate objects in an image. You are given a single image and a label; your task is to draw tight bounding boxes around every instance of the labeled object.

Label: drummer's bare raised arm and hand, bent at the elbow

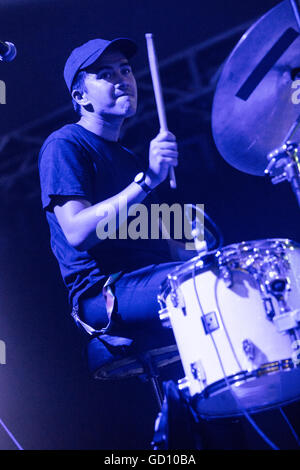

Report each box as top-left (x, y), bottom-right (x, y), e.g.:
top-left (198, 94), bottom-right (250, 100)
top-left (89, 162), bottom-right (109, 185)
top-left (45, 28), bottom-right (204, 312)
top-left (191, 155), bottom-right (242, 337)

top-left (54, 132), bottom-right (178, 251)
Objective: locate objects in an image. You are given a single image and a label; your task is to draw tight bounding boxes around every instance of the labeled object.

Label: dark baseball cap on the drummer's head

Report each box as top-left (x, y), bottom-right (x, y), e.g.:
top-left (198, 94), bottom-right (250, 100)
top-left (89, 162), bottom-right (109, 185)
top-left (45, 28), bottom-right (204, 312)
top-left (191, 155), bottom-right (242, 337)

top-left (64, 38), bottom-right (137, 92)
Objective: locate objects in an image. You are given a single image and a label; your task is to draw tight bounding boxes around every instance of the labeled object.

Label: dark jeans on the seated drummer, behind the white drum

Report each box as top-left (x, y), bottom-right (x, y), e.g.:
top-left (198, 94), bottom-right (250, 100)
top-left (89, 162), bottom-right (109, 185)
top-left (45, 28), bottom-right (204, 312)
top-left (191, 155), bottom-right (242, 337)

top-left (79, 262), bottom-right (182, 360)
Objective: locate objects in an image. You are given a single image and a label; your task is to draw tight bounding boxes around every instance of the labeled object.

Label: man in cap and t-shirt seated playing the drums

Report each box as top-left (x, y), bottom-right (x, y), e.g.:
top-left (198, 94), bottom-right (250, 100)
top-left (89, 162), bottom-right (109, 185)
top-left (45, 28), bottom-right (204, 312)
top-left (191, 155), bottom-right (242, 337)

top-left (39, 38), bottom-right (190, 358)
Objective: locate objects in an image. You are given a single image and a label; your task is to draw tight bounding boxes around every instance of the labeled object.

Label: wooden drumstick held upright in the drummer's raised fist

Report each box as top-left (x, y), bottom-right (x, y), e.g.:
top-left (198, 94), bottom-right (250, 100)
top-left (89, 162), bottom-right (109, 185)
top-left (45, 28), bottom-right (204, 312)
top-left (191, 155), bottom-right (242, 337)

top-left (145, 33), bottom-right (176, 189)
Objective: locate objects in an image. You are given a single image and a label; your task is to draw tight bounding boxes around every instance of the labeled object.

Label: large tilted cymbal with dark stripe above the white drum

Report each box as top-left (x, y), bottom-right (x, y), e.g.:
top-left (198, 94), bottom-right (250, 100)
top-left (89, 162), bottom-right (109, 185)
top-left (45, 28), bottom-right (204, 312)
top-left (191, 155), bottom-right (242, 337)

top-left (212, 0), bottom-right (300, 176)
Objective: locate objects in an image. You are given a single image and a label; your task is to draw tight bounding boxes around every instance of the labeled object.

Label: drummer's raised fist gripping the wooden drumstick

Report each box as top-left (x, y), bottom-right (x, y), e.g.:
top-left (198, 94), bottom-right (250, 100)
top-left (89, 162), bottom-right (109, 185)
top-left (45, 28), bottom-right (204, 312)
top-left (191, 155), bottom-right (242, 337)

top-left (146, 131), bottom-right (178, 187)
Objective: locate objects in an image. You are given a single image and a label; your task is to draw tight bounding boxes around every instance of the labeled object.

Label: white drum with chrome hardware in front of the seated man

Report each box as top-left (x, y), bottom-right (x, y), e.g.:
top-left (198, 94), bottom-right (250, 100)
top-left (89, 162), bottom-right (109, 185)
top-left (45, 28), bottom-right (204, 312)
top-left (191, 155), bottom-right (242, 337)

top-left (158, 239), bottom-right (300, 416)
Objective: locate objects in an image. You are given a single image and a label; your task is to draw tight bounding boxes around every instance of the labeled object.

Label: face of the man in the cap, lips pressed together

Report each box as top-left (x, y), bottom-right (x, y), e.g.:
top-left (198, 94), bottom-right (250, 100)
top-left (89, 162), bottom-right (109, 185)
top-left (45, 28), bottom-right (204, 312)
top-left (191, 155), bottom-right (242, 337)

top-left (79, 50), bottom-right (137, 118)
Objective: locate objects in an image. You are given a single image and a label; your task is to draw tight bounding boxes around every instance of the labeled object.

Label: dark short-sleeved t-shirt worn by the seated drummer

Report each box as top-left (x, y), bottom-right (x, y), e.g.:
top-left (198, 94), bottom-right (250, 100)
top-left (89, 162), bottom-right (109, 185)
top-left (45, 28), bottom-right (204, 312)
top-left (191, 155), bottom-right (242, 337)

top-left (39, 124), bottom-right (173, 304)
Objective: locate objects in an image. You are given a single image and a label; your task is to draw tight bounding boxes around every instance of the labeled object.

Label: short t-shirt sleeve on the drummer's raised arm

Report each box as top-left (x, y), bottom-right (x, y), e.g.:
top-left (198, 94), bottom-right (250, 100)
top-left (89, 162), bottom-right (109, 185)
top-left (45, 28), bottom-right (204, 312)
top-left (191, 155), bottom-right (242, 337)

top-left (39, 138), bottom-right (92, 210)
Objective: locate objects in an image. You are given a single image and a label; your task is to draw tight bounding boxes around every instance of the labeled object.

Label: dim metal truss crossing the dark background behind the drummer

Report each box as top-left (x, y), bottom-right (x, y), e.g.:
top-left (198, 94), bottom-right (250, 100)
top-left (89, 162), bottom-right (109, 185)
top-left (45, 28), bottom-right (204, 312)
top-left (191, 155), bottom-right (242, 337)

top-left (0, 20), bottom-right (255, 200)
